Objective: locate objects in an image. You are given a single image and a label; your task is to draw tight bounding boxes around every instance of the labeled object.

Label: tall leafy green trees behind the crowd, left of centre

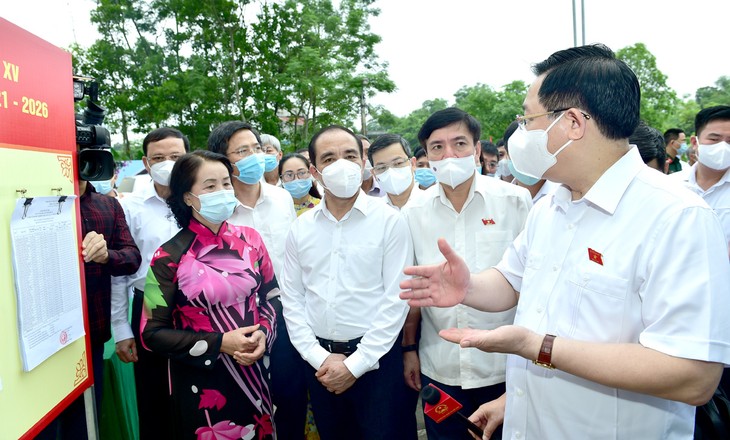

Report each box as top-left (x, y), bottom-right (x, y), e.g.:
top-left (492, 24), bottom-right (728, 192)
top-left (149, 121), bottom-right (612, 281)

top-left (72, 0), bottom-right (395, 156)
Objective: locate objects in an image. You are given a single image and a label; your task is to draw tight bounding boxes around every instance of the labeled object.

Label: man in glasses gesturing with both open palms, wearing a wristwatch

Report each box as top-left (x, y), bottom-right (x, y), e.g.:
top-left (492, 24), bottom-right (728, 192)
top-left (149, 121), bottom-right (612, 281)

top-left (401, 45), bottom-right (730, 440)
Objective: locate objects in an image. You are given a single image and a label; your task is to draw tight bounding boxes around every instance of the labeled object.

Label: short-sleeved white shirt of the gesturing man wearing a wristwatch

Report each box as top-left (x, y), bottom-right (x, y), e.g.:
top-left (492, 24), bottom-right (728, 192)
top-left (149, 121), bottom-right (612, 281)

top-left (497, 148), bottom-right (730, 440)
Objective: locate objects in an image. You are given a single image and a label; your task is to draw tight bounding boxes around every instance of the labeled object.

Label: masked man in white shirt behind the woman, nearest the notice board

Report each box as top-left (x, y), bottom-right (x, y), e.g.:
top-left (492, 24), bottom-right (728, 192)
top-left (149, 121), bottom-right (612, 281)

top-left (111, 127), bottom-right (190, 440)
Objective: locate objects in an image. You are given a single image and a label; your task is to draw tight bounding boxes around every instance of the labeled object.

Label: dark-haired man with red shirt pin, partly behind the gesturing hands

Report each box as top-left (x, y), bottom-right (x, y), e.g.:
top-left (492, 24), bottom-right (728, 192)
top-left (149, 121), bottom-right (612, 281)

top-left (402, 107), bottom-right (532, 440)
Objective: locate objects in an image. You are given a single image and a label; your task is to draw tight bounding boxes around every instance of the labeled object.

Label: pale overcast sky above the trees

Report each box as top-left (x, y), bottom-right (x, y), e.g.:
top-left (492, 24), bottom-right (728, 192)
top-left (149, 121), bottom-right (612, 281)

top-left (0, 0), bottom-right (730, 116)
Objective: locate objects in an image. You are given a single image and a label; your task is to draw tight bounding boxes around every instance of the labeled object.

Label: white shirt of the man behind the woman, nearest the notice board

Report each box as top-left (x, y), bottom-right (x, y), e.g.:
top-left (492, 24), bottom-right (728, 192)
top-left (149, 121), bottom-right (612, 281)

top-left (111, 184), bottom-right (180, 342)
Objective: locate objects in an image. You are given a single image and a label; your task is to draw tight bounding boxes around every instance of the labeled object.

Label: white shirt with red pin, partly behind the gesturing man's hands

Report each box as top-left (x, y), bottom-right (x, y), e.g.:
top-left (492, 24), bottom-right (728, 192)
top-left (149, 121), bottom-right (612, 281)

top-left (401, 174), bottom-right (532, 388)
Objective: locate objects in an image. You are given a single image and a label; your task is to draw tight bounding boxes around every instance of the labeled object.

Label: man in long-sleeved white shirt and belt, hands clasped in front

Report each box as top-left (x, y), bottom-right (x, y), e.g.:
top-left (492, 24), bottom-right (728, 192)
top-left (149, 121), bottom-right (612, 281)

top-left (277, 126), bottom-right (416, 440)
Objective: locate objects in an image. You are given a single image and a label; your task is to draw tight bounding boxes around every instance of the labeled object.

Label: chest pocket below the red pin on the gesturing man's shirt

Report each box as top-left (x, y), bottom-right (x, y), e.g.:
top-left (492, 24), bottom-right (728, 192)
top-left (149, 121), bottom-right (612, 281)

top-left (559, 267), bottom-right (629, 343)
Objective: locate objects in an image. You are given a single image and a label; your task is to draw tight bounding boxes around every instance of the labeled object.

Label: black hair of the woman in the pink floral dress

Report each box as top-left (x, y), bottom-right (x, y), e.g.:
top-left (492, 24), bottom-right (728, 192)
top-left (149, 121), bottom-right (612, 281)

top-left (167, 150), bottom-right (233, 228)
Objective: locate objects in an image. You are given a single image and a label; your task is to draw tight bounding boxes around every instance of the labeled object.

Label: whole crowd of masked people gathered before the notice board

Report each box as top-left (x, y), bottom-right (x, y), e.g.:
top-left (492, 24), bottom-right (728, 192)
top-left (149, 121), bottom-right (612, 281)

top-left (47, 45), bottom-right (730, 440)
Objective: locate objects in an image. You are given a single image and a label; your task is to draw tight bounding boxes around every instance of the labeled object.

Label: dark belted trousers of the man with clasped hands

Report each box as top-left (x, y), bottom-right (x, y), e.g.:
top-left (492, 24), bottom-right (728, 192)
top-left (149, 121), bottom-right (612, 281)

top-left (307, 341), bottom-right (417, 440)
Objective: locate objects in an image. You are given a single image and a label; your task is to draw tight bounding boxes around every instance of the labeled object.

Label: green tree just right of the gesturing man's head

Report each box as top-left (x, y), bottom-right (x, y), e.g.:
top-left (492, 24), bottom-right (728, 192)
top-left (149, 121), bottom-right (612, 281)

top-left (616, 43), bottom-right (679, 129)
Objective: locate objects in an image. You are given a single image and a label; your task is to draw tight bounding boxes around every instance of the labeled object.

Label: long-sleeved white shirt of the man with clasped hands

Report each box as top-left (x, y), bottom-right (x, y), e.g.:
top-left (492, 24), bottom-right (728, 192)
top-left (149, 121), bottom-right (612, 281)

top-left (281, 190), bottom-right (413, 378)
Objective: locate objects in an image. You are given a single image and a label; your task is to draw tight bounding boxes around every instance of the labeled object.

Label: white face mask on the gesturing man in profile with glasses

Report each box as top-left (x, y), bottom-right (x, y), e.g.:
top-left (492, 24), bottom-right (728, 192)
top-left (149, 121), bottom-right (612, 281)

top-left (509, 113), bottom-right (573, 179)
